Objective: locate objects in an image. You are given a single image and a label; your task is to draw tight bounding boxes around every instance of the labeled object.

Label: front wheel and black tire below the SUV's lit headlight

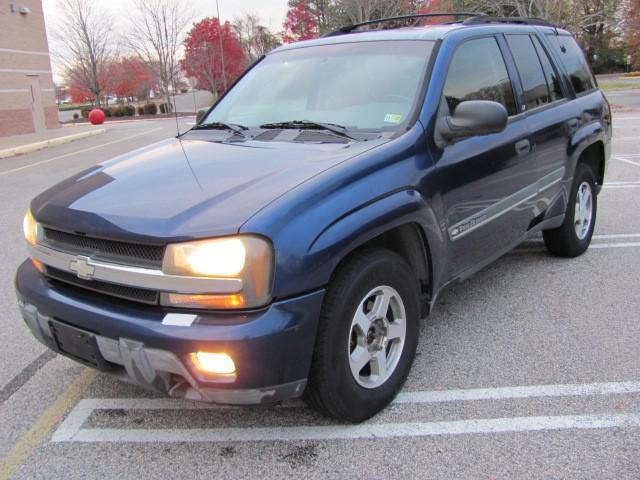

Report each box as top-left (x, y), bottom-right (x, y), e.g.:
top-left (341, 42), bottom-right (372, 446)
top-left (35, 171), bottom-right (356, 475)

top-left (303, 248), bottom-right (420, 422)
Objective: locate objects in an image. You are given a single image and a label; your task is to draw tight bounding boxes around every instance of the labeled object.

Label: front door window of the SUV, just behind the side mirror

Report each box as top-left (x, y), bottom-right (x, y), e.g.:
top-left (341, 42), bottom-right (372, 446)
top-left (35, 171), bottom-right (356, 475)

top-left (444, 37), bottom-right (517, 115)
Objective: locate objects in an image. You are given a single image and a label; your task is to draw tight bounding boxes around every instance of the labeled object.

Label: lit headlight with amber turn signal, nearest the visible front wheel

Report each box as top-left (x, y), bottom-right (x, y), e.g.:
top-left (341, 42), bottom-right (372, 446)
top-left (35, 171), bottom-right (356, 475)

top-left (161, 235), bottom-right (273, 309)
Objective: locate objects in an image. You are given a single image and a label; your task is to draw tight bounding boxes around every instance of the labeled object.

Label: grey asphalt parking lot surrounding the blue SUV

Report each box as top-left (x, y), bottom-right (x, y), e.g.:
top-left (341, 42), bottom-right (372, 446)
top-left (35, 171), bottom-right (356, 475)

top-left (0, 112), bottom-right (640, 479)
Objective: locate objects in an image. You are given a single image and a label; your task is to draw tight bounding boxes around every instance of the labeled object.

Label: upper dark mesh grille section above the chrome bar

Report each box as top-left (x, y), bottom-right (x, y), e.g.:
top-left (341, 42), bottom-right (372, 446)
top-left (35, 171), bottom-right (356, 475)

top-left (42, 228), bottom-right (164, 269)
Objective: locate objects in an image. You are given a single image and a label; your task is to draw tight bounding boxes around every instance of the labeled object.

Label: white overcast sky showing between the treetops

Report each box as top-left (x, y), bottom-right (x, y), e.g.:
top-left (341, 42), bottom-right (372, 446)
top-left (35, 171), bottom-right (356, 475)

top-left (42, 0), bottom-right (287, 81)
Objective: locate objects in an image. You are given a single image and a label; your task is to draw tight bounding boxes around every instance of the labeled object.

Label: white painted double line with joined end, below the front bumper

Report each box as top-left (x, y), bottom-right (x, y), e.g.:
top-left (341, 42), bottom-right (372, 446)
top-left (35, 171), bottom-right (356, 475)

top-left (51, 381), bottom-right (640, 442)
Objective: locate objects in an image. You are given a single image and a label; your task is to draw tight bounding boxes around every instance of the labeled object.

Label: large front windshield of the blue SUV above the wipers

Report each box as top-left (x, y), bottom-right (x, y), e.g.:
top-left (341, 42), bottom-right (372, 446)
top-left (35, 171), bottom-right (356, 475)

top-left (203, 40), bottom-right (433, 129)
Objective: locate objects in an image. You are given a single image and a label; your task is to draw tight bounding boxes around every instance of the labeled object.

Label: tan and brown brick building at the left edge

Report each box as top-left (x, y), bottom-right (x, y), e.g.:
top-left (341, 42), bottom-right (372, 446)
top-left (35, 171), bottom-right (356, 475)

top-left (0, 0), bottom-right (60, 136)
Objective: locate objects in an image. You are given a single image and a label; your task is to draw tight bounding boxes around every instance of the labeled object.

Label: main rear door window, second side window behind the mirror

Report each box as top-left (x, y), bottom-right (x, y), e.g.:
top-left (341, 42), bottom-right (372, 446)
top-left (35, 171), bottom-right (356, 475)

top-left (506, 35), bottom-right (551, 110)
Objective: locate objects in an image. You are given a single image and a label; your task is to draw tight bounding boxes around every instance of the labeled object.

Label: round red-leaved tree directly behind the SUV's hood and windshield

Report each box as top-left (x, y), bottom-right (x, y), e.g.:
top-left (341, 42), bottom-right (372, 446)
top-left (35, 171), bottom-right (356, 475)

top-left (180, 17), bottom-right (245, 95)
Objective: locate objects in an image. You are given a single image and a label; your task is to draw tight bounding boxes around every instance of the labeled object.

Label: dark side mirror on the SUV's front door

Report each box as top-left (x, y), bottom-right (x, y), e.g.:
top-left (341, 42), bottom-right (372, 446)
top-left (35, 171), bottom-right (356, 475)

top-left (438, 100), bottom-right (509, 141)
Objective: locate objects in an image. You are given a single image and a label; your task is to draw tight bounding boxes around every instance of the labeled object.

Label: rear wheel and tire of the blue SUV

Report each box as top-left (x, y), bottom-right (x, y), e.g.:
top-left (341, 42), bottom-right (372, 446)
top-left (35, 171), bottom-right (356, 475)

top-left (542, 163), bottom-right (598, 258)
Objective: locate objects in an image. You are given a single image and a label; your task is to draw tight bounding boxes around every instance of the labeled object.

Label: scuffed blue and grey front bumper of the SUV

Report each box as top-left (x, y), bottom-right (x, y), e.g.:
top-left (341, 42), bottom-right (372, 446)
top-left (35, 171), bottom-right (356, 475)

top-left (16, 261), bottom-right (324, 404)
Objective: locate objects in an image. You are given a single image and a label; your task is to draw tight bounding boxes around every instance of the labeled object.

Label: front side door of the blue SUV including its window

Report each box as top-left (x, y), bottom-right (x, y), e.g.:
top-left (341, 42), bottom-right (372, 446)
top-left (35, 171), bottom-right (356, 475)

top-left (436, 36), bottom-right (536, 277)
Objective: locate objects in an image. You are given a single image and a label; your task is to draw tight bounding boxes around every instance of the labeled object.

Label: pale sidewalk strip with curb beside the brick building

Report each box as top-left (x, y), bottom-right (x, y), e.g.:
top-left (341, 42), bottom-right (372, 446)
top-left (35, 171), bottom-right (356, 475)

top-left (0, 125), bottom-right (107, 159)
